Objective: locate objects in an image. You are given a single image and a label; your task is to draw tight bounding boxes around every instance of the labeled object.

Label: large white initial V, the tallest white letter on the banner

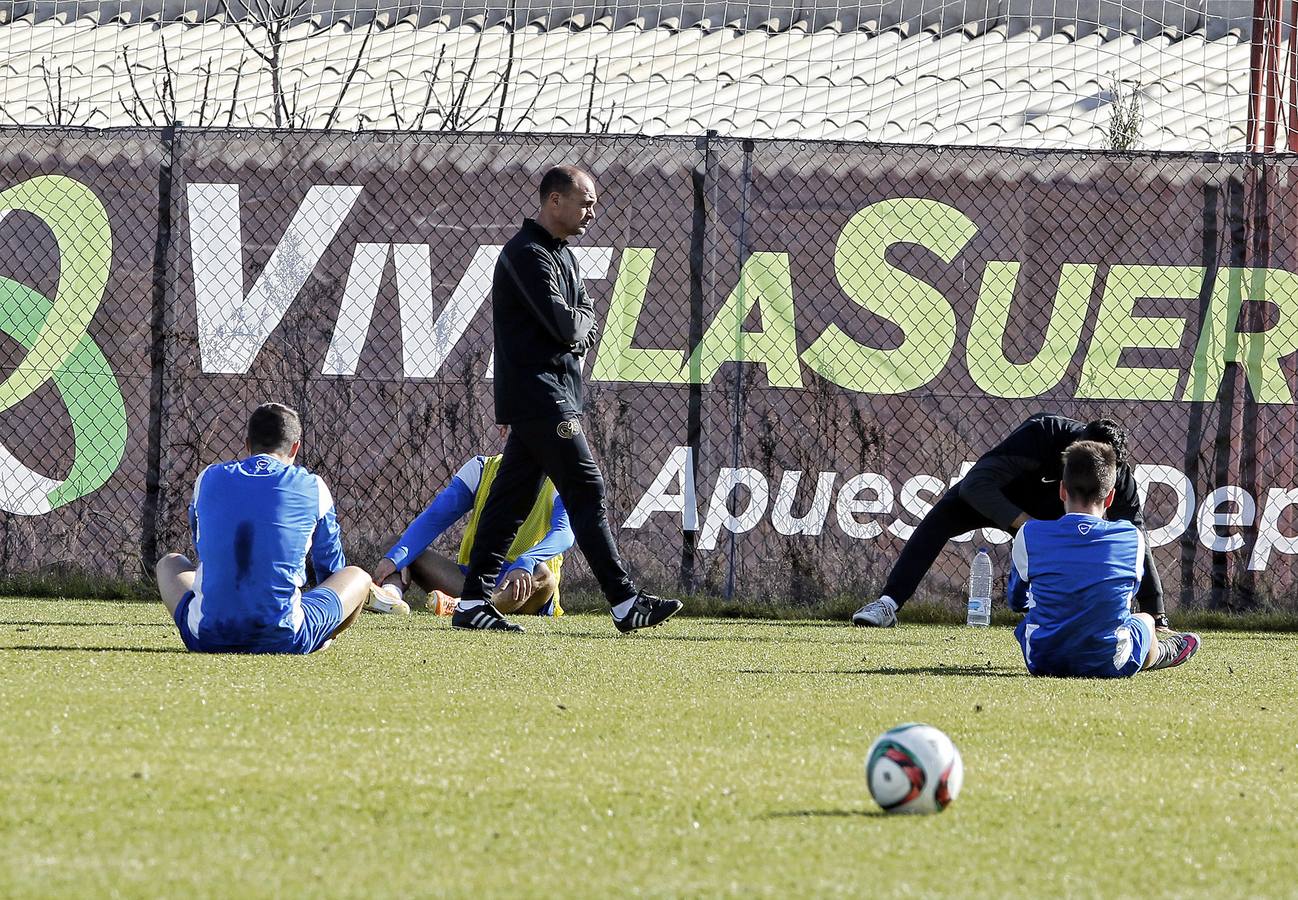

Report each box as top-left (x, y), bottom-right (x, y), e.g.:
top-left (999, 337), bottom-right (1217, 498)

top-left (186, 182), bottom-right (361, 375)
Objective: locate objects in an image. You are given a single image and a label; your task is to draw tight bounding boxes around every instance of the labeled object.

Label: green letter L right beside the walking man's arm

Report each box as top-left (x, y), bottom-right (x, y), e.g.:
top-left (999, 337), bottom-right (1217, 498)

top-left (591, 247), bottom-right (685, 384)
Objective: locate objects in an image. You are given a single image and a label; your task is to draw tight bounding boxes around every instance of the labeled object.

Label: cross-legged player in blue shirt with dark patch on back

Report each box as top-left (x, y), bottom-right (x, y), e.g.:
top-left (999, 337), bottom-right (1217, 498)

top-left (156, 403), bottom-right (370, 653)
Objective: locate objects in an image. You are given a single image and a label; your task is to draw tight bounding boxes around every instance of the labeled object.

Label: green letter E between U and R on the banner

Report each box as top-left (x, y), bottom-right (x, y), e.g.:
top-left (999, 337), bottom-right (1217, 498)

top-left (1077, 265), bottom-right (1205, 400)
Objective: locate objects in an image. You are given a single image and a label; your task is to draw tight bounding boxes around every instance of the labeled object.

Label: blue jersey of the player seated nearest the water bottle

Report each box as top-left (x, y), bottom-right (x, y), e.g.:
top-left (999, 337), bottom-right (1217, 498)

top-left (1014, 513), bottom-right (1145, 675)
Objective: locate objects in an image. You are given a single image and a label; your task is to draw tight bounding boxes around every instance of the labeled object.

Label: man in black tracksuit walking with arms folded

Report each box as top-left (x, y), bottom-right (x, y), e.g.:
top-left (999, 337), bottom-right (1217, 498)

top-left (450, 166), bottom-right (681, 632)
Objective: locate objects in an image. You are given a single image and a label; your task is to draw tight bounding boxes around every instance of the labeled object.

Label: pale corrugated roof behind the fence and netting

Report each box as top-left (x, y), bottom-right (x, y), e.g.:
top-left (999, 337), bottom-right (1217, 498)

top-left (0, 0), bottom-right (1249, 151)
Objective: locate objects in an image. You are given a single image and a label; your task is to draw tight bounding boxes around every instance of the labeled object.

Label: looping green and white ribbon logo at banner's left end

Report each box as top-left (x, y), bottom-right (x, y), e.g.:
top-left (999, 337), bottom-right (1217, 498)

top-left (0, 175), bottom-right (126, 516)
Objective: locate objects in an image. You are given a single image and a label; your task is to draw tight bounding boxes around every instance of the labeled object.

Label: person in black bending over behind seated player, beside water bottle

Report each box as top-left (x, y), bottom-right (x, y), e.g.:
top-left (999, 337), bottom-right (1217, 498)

top-left (851, 413), bottom-right (1167, 629)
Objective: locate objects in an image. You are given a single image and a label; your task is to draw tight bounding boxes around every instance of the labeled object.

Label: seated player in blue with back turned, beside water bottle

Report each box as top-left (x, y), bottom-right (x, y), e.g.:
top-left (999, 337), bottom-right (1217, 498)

top-left (1010, 440), bottom-right (1199, 678)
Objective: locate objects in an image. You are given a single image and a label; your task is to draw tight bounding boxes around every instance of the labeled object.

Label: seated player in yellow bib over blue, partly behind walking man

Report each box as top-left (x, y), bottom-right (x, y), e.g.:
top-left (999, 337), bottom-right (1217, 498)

top-left (366, 456), bottom-right (574, 616)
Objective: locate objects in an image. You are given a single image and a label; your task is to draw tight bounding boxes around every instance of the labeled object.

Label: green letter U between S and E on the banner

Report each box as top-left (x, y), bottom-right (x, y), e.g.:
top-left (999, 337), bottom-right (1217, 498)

top-left (964, 260), bottom-right (1097, 397)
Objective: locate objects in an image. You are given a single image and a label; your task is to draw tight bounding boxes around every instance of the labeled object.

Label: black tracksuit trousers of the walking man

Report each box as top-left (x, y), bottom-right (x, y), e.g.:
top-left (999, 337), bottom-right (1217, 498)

top-left (463, 417), bottom-right (636, 605)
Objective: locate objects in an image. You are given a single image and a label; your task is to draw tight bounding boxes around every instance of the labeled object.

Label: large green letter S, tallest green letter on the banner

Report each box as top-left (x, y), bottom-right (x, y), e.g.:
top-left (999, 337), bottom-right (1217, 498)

top-left (802, 197), bottom-right (977, 394)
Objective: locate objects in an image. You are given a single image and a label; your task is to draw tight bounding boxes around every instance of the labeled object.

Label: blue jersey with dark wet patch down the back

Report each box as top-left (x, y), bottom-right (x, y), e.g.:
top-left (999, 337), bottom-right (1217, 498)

top-left (187, 455), bottom-right (347, 647)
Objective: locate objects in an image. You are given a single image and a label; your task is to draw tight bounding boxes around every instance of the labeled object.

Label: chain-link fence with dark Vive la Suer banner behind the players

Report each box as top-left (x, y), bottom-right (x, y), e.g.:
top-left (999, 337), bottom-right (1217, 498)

top-left (0, 130), bottom-right (1298, 610)
